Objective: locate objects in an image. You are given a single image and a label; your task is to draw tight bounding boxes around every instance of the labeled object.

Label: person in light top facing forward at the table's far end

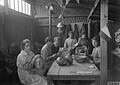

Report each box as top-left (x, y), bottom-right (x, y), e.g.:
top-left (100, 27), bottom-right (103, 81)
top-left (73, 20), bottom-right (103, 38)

top-left (64, 31), bottom-right (77, 49)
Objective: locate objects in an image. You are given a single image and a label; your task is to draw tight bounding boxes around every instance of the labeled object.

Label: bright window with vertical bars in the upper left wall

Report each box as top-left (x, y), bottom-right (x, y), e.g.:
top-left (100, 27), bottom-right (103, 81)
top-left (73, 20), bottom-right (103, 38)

top-left (8, 0), bottom-right (31, 15)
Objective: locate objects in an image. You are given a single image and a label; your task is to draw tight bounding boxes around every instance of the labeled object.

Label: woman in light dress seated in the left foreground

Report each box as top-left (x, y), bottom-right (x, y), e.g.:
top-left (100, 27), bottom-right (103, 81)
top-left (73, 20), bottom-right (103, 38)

top-left (17, 39), bottom-right (47, 85)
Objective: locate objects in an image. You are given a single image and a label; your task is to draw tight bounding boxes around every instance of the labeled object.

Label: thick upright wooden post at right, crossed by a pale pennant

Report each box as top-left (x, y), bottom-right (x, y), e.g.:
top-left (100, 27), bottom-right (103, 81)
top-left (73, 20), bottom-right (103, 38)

top-left (100, 0), bottom-right (108, 85)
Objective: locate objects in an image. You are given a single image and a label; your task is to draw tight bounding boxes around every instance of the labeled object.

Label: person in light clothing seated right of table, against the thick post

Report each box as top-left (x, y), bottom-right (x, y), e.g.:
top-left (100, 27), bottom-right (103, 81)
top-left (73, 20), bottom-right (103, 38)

top-left (91, 36), bottom-right (101, 69)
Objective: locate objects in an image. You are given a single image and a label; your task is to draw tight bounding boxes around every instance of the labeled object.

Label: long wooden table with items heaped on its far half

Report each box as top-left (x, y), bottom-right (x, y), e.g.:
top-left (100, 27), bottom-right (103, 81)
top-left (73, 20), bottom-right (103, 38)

top-left (47, 61), bottom-right (100, 84)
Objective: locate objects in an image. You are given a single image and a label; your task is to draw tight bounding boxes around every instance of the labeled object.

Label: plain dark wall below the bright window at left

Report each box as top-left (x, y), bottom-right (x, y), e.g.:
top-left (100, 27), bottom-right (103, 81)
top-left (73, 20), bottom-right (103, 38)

top-left (0, 7), bottom-right (34, 50)
